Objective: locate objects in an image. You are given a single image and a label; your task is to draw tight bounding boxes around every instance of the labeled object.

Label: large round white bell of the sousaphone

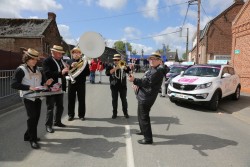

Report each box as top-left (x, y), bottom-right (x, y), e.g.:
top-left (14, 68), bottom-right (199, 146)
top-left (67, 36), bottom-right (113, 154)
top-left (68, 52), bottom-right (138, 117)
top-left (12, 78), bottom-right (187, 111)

top-left (79, 32), bottom-right (105, 58)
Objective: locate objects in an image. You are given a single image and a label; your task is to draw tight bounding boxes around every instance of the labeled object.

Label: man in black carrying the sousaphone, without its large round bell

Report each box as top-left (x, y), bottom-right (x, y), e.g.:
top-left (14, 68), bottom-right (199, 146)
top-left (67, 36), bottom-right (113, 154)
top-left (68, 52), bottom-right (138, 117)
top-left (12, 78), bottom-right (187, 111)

top-left (68, 47), bottom-right (90, 121)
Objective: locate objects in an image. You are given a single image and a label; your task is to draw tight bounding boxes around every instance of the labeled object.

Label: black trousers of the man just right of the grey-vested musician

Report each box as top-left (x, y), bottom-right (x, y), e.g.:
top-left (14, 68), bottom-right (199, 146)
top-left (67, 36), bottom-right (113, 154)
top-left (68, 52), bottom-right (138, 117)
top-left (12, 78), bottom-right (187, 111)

top-left (45, 94), bottom-right (63, 126)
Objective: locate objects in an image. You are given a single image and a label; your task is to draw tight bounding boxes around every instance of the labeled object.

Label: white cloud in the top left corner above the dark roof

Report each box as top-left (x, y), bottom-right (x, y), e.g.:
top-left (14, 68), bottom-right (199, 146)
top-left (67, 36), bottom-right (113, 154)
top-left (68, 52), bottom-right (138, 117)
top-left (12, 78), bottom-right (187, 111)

top-left (0, 0), bottom-right (62, 18)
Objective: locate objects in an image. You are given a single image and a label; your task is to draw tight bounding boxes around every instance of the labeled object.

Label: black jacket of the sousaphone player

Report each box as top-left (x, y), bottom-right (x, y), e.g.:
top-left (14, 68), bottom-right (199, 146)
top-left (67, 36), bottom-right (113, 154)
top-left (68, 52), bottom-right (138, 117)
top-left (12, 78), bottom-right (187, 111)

top-left (67, 59), bottom-right (90, 84)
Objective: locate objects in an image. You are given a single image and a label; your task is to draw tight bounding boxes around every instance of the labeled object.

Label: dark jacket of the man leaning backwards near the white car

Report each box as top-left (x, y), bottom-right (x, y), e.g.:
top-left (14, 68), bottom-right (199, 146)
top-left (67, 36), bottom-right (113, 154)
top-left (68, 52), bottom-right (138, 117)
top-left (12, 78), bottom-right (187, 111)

top-left (133, 66), bottom-right (165, 104)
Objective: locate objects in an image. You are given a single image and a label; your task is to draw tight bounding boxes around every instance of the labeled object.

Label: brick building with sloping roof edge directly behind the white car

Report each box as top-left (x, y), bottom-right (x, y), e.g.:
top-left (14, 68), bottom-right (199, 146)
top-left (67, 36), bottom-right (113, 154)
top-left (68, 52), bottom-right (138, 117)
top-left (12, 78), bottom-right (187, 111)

top-left (189, 0), bottom-right (244, 64)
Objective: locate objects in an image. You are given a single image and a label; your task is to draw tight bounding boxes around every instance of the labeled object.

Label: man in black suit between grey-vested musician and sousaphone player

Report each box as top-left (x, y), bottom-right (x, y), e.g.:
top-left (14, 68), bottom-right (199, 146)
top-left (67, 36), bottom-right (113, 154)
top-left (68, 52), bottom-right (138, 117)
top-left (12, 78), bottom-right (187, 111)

top-left (43, 45), bottom-right (69, 133)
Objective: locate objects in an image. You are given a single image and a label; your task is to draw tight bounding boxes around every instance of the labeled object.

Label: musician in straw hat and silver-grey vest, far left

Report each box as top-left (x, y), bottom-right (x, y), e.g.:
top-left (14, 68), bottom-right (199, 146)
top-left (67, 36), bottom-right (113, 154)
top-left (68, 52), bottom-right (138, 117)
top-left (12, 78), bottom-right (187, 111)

top-left (11, 48), bottom-right (53, 149)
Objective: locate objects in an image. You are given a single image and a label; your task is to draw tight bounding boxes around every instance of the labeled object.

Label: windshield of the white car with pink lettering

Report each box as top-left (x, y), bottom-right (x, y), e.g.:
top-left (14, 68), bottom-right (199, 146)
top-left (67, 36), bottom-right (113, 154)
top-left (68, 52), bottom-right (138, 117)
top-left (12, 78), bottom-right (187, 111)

top-left (184, 66), bottom-right (220, 77)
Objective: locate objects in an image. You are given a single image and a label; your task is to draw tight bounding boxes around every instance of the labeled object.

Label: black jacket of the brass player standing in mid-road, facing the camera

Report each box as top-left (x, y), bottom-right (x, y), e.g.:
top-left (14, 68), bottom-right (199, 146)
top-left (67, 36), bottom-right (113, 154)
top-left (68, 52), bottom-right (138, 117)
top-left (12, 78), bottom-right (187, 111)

top-left (105, 65), bottom-right (131, 87)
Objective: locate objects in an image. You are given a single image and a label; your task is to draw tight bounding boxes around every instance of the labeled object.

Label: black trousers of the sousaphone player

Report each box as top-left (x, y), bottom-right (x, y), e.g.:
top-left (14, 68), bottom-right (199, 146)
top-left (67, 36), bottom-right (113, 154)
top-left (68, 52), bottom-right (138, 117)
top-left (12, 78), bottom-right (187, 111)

top-left (68, 83), bottom-right (86, 118)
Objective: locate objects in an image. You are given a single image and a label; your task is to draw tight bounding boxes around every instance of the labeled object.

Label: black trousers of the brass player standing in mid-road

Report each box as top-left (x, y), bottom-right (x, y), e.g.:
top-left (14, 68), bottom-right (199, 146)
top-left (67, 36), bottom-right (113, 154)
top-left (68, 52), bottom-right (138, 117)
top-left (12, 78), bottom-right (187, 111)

top-left (110, 86), bottom-right (128, 115)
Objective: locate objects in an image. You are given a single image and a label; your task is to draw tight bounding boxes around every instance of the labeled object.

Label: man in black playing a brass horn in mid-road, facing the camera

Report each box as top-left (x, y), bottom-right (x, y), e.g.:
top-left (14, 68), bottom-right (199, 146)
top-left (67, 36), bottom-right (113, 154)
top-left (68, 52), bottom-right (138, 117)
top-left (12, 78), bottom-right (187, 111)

top-left (106, 54), bottom-right (131, 119)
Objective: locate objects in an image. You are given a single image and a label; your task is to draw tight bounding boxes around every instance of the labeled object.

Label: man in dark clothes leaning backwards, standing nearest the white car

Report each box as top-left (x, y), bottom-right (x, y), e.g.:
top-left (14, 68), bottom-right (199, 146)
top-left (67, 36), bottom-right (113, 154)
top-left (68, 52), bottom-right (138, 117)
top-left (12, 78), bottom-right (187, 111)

top-left (128, 52), bottom-right (165, 144)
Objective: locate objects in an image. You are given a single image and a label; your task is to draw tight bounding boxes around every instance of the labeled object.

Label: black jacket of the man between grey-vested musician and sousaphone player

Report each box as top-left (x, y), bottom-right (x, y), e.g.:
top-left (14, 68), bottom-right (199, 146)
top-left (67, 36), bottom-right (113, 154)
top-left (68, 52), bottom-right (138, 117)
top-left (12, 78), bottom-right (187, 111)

top-left (43, 56), bottom-right (66, 91)
